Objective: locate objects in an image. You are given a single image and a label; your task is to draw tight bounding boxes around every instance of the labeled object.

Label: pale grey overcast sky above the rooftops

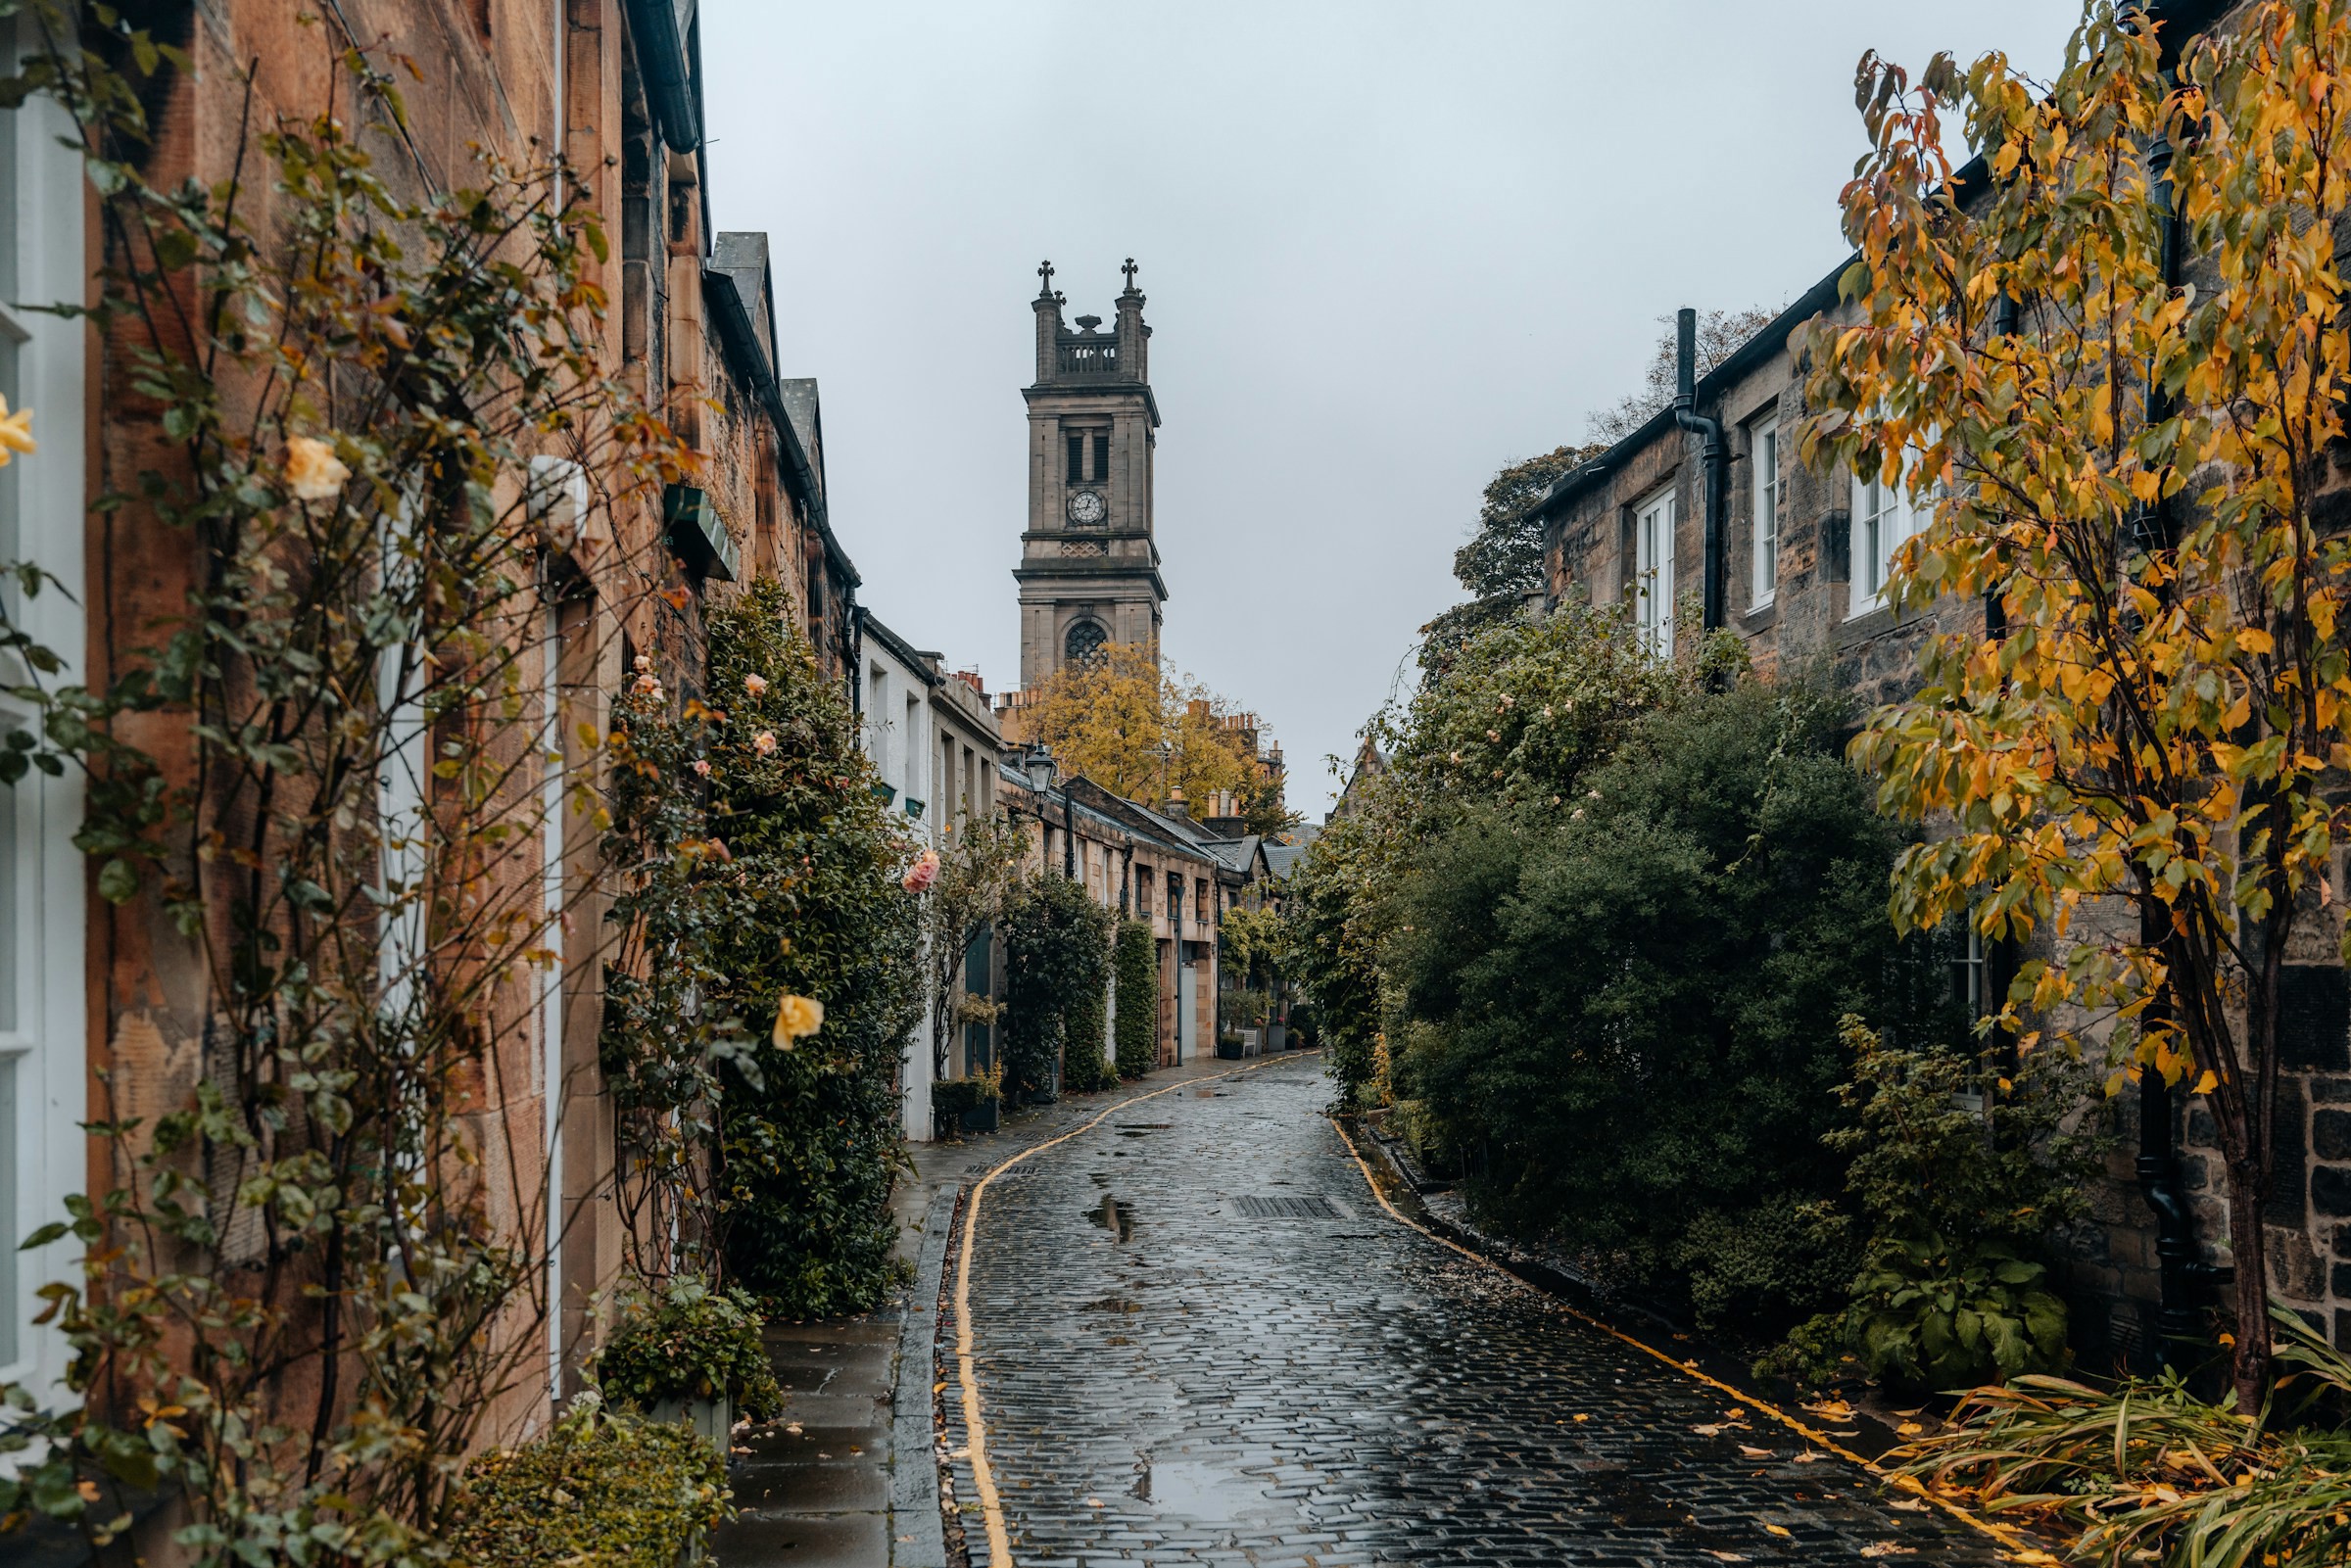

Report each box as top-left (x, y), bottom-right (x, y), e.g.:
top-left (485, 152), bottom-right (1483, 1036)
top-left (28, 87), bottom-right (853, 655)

top-left (703, 0), bottom-right (2079, 818)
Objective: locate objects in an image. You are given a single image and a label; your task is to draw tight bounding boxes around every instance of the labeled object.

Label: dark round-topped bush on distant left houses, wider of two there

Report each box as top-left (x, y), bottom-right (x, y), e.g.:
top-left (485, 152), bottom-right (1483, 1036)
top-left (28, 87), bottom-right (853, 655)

top-left (1004, 873), bottom-right (1112, 1093)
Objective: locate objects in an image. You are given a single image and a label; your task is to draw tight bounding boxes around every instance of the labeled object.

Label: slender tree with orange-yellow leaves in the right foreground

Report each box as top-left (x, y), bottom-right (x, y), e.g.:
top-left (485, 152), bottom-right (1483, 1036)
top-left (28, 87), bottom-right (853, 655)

top-left (1803, 0), bottom-right (2351, 1410)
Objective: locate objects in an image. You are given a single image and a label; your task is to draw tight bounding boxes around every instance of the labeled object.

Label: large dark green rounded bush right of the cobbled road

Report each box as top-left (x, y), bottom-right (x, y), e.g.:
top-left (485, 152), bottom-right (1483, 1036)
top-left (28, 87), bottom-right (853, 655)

top-left (1385, 682), bottom-right (1958, 1328)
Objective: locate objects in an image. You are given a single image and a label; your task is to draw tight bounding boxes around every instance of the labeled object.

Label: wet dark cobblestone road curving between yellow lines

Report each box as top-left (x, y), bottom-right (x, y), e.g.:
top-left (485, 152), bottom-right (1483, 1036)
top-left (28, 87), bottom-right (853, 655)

top-left (942, 1061), bottom-right (2005, 1568)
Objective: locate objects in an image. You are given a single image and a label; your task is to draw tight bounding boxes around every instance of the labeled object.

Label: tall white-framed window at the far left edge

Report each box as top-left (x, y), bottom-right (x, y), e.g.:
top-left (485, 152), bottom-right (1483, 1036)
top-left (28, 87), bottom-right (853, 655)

top-left (0, 17), bottom-right (89, 1403)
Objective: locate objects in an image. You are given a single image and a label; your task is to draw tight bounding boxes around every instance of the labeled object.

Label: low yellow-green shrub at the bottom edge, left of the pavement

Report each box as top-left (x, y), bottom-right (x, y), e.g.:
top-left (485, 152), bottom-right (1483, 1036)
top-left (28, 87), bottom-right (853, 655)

top-left (449, 1394), bottom-right (727, 1568)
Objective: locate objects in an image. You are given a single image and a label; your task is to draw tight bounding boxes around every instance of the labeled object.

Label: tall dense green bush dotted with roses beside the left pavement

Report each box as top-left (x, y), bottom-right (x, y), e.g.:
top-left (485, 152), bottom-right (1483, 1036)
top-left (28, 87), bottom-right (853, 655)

top-left (703, 578), bottom-right (922, 1316)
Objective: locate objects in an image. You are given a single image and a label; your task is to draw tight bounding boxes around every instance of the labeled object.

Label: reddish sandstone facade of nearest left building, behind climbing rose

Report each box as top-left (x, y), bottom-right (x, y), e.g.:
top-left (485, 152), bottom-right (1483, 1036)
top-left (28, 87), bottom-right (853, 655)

top-left (0, 0), bottom-right (879, 1495)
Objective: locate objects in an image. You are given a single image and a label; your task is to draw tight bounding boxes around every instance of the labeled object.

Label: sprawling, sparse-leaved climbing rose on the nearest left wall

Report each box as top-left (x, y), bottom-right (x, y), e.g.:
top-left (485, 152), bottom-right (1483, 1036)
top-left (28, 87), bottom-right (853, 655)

top-left (0, 5), bottom-right (687, 1566)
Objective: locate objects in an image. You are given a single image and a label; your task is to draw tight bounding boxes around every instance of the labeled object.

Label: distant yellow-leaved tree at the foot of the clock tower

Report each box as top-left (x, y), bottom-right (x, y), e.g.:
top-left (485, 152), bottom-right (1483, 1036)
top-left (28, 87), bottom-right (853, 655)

top-left (1023, 641), bottom-right (1291, 832)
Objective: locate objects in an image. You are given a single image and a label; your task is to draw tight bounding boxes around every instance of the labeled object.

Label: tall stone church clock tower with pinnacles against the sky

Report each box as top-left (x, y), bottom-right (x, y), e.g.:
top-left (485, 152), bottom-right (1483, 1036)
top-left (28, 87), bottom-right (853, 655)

top-left (1013, 259), bottom-right (1169, 687)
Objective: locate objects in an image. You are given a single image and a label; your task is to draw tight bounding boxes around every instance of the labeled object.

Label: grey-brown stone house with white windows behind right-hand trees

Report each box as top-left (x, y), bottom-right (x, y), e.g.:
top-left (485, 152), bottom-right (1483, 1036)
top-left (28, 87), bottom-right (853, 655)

top-left (1538, 0), bottom-right (2351, 1363)
